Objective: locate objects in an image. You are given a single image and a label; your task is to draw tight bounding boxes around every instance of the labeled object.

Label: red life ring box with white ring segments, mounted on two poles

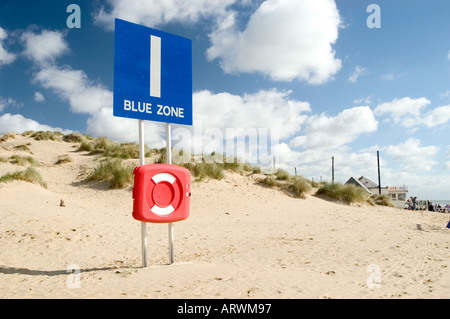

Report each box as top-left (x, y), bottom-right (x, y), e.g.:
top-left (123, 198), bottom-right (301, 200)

top-left (133, 164), bottom-right (191, 223)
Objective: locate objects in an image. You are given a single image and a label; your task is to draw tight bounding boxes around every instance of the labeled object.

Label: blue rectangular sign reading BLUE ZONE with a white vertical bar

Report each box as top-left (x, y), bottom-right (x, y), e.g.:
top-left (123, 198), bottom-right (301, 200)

top-left (113, 19), bottom-right (192, 125)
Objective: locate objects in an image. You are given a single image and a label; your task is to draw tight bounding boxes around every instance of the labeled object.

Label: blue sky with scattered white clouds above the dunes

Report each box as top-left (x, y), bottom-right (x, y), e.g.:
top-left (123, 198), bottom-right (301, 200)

top-left (0, 0), bottom-right (450, 199)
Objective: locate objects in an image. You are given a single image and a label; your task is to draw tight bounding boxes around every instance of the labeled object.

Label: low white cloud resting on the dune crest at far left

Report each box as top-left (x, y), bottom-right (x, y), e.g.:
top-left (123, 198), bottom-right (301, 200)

top-left (0, 113), bottom-right (71, 134)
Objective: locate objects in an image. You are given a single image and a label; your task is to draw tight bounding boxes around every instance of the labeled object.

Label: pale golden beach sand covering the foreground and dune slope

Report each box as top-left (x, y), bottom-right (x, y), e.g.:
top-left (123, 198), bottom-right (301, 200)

top-left (0, 134), bottom-right (450, 299)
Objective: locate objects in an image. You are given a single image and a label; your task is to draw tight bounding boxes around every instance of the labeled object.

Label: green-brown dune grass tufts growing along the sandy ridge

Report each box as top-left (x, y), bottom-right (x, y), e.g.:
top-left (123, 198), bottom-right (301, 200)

top-left (0, 131), bottom-right (392, 206)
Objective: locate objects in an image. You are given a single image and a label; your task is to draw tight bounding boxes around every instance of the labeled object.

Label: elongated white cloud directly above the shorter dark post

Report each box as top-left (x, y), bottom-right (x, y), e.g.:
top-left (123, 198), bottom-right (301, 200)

top-left (290, 106), bottom-right (378, 149)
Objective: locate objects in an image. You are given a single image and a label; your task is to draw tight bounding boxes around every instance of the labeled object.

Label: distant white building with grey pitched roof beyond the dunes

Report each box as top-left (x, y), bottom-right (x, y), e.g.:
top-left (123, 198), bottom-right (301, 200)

top-left (345, 176), bottom-right (408, 208)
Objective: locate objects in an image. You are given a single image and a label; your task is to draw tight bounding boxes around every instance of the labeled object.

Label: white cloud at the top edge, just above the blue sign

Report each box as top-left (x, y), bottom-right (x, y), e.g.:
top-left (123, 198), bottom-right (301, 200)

top-left (94, 0), bottom-right (236, 30)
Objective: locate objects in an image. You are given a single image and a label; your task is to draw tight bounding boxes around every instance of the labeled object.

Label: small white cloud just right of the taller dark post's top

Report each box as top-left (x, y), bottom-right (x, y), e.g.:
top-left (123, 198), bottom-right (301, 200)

top-left (385, 138), bottom-right (439, 173)
